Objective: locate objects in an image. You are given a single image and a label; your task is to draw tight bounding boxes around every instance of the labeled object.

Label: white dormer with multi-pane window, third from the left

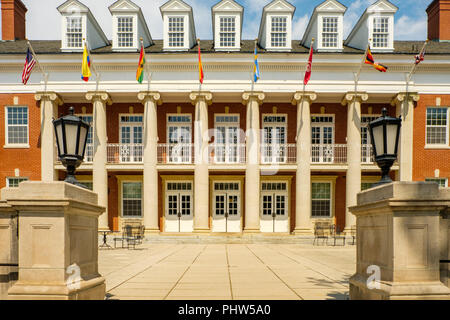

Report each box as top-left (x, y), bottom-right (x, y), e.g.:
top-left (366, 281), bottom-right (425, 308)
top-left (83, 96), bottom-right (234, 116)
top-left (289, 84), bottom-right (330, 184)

top-left (159, 0), bottom-right (197, 51)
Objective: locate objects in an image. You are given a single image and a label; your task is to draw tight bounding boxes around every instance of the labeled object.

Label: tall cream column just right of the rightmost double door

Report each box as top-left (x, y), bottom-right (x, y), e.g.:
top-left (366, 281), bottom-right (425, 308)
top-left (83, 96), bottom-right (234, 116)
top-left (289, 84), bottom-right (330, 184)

top-left (292, 92), bottom-right (317, 235)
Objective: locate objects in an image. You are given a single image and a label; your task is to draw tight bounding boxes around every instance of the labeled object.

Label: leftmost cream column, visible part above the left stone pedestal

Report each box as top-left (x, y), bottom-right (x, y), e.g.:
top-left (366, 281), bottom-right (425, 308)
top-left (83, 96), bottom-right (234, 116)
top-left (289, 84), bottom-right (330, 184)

top-left (34, 92), bottom-right (63, 182)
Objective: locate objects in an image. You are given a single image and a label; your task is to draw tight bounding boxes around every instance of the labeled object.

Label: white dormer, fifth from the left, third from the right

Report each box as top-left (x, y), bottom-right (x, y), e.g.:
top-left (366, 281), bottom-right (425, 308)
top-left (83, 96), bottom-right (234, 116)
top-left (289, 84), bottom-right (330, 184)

top-left (258, 0), bottom-right (295, 51)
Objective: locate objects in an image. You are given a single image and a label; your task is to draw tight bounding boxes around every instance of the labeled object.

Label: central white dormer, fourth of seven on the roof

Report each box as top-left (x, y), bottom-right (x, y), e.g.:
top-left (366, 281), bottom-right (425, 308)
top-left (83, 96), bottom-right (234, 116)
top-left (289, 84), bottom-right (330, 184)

top-left (212, 0), bottom-right (244, 51)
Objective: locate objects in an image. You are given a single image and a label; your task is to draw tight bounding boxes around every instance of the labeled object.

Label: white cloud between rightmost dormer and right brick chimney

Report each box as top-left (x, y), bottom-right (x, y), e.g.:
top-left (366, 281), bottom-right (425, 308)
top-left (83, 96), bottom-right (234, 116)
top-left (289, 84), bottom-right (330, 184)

top-left (395, 15), bottom-right (428, 40)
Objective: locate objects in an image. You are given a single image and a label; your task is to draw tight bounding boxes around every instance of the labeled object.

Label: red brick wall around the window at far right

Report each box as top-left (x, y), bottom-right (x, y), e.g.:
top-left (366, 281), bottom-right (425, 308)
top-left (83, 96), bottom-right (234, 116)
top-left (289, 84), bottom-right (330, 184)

top-left (413, 95), bottom-right (450, 181)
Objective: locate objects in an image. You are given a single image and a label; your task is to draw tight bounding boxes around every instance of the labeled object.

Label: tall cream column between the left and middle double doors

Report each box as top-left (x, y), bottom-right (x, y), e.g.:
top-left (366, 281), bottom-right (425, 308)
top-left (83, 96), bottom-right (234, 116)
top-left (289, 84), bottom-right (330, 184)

top-left (190, 92), bottom-right (212, 232)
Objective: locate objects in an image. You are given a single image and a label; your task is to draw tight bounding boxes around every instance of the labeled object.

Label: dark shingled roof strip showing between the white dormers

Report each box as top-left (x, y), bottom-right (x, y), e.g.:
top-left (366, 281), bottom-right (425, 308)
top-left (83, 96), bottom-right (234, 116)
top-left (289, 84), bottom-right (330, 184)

top-left (0, 40), bottom-right (450, 55)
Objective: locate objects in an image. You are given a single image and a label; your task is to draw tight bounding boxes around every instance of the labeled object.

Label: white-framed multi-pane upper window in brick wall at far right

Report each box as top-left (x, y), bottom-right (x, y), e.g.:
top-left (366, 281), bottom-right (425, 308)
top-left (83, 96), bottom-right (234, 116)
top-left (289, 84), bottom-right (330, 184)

top-left (426, 108), bottom-right (448, 145)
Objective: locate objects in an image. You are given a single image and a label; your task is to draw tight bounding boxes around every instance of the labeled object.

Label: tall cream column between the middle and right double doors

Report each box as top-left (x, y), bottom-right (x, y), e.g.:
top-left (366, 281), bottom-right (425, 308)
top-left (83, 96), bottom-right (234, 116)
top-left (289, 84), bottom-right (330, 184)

top-left (242, 92), bottom-right (265, 233)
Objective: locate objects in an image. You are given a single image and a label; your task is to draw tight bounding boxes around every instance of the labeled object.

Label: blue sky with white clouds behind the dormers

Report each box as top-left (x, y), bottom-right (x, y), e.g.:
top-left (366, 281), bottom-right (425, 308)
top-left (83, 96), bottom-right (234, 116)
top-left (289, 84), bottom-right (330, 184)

top-left (0, 0), bottom-right (432, 40)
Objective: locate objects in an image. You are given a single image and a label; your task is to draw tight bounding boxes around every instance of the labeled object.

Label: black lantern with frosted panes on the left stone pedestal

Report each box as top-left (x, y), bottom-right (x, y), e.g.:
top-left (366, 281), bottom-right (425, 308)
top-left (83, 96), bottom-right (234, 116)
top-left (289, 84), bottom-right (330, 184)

top-left (53, 107), bottom-right (90, 188)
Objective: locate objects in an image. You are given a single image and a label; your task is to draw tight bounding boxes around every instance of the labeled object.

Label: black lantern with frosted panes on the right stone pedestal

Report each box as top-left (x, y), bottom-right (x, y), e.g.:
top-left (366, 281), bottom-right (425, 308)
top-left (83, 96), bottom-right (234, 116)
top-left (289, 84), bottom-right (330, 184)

top-left (369, 108), bottom-right (402, 186)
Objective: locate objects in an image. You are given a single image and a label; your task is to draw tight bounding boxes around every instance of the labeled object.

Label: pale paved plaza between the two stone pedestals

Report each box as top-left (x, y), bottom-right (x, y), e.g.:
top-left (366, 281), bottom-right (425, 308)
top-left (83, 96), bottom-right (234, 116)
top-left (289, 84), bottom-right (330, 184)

top-left (99, 241), bottom-right (356, 300)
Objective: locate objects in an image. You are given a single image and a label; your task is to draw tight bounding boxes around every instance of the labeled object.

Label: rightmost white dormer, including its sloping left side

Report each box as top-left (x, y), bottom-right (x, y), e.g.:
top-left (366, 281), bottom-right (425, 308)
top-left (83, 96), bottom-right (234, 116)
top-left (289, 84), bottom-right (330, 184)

top-left (344, 0), bottom-right (398, 52)
